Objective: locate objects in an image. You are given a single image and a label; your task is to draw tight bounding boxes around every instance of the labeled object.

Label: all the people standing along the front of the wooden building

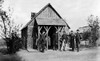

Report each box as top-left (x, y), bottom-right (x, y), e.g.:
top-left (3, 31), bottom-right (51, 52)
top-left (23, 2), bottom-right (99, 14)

top-left (37, 30), bottom-right (81, 52)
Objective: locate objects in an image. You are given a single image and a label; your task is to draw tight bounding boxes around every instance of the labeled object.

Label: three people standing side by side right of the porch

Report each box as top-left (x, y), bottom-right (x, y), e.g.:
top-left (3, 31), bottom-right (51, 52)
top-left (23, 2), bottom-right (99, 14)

top-left (58, 30), bottom-right (81, 52)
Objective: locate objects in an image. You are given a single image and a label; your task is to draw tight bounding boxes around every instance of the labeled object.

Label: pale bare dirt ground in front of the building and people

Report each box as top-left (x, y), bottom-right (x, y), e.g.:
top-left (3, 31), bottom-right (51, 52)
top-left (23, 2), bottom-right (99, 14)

top-left (17, 47), bottom-right (100, 61)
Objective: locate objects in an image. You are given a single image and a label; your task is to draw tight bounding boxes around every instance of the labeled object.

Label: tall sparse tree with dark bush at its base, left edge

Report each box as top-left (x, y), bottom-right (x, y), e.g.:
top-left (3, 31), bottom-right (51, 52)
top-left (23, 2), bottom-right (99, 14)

top-left (0, 0), bottom-right (22, 53)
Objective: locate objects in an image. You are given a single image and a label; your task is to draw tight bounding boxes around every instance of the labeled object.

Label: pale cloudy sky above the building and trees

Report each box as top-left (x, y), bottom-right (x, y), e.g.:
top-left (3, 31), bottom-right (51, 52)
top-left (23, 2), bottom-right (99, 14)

top-left (3, 0), bottom-right (100, 30)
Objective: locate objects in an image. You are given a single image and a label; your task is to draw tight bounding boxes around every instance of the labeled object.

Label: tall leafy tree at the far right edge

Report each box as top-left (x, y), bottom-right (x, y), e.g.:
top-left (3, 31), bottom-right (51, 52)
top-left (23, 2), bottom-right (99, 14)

top-left (88, 15), bottom-right (99, 46)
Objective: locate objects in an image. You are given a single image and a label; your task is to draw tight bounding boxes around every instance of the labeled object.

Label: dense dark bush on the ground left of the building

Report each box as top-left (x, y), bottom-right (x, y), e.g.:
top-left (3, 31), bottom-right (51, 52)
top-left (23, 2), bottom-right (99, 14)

top-left (7, 32), bottom-right (22, 53)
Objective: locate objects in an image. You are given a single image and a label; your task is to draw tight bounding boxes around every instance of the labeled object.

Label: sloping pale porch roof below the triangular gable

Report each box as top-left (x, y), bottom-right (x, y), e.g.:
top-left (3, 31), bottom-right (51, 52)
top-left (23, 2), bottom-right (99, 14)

top-left (36, 18), bottom-right (66, 26)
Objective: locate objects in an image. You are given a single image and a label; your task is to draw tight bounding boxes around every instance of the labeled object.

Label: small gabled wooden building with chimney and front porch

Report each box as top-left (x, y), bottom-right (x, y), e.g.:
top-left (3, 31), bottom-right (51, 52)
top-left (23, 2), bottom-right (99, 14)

top-left (21, 3), bottom-right (70, 49)
